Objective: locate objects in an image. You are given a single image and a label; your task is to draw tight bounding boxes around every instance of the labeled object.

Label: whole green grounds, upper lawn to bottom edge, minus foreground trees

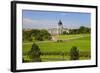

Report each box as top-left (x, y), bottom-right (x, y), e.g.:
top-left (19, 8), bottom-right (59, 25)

top-left (23, 34), bottom-right (91, 62)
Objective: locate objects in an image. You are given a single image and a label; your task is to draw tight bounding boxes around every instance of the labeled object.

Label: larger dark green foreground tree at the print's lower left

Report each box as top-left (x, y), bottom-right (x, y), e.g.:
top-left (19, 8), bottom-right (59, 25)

top-left (29, 43), bottom-right (41, 62)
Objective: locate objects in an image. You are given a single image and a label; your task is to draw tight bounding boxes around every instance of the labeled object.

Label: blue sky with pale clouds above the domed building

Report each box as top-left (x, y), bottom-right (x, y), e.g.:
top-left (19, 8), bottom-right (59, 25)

top-left (22, 10), bottom-right (91, 29)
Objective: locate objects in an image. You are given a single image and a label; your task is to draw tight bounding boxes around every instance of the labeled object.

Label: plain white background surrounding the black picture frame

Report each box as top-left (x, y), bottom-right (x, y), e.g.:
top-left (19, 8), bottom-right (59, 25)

top-left (0, 0), bottom-right (100, 73)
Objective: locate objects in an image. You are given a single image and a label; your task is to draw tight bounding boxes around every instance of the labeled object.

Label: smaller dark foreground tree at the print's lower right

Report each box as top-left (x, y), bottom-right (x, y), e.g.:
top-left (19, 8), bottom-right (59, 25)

top-left (70, 46), bottom-right (79, 60)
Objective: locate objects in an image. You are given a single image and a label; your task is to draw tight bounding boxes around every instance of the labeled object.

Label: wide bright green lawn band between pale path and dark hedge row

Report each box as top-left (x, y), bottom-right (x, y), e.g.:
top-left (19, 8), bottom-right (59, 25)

top-left (23, 35), bottom-right (91, 53)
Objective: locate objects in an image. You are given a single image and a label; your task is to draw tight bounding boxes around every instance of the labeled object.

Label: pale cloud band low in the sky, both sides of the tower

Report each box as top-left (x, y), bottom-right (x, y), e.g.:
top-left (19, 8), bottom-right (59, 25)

top-left (23, 18), bottom-right (90, 29)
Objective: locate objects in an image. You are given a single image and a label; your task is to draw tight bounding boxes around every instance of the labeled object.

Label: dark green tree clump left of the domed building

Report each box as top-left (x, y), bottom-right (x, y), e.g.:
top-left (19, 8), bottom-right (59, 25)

top-left (23, 29), bottom-right (51, 41)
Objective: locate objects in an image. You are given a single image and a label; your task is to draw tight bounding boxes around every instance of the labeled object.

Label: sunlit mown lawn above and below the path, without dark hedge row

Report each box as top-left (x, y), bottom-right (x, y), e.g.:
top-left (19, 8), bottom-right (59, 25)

top-left (23, 34), bottom-right (91, 61)
